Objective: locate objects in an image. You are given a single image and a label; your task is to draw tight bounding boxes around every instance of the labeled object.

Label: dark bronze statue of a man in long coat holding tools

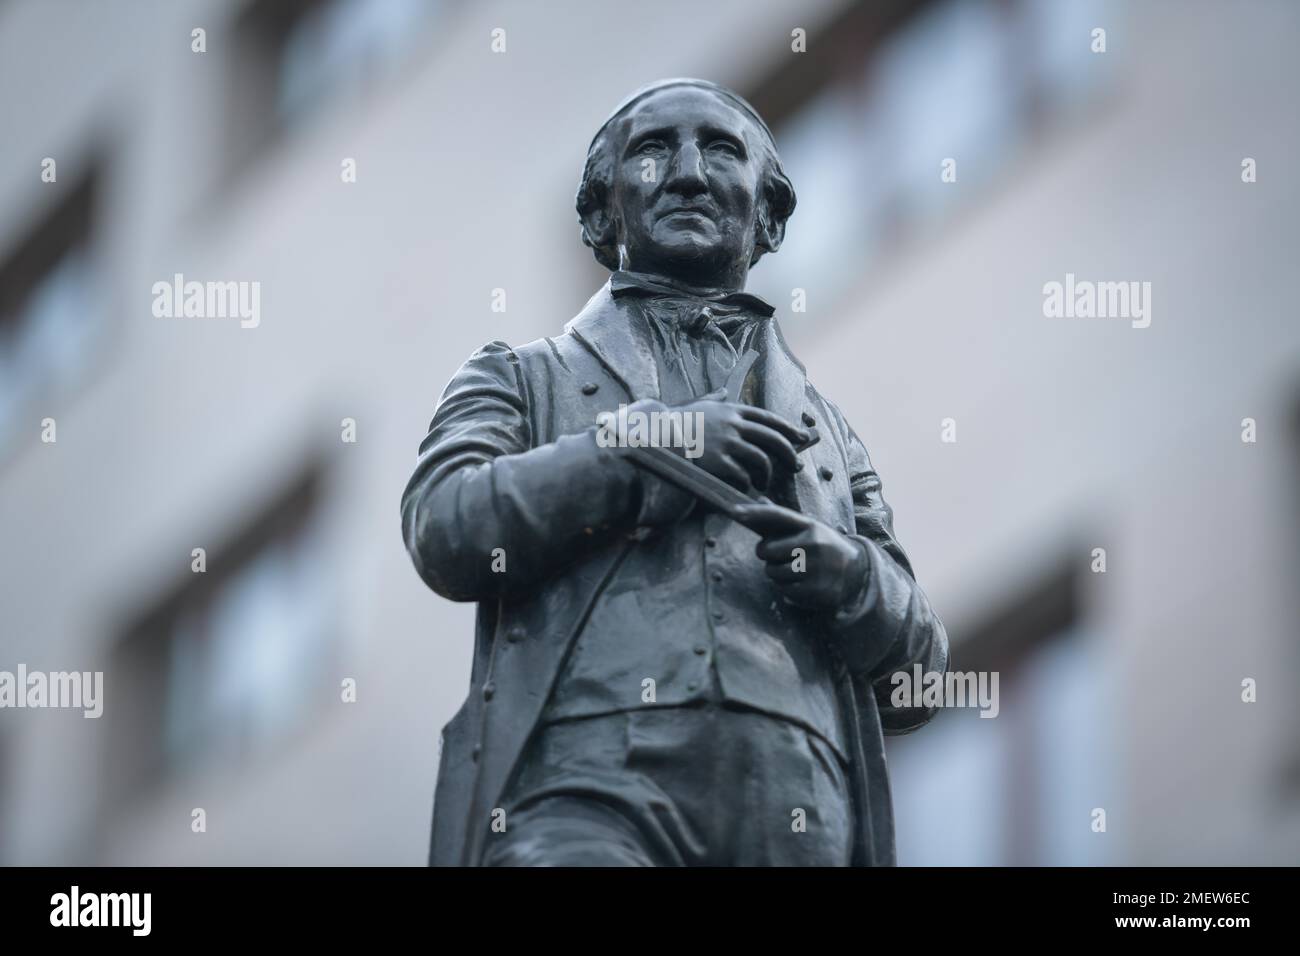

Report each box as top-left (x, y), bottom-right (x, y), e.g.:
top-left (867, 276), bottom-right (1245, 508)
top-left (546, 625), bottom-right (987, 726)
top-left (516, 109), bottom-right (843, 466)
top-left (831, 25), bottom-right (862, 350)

top-left (402, 79), bottom-right (948, 865)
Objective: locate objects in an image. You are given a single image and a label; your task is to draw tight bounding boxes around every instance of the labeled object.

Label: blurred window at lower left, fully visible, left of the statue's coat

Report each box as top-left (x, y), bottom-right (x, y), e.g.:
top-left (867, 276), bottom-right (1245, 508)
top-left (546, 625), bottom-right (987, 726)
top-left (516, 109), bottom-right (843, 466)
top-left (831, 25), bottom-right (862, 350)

top-left (105, 471), bottom-right (337, 792)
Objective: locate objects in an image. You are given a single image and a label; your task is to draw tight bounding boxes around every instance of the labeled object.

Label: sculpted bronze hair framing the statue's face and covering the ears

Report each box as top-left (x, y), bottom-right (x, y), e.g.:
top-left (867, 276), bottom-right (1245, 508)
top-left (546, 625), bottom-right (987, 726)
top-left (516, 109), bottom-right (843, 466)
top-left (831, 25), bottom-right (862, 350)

top-left (576, 79), bottom-right (796, 272)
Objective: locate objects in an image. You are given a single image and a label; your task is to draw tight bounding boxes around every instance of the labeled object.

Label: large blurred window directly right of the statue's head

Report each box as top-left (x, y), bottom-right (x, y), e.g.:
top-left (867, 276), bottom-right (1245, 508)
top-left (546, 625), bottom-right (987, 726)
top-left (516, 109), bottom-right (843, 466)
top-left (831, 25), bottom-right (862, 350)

top-left (751, 0), bottom-right (1114, 312)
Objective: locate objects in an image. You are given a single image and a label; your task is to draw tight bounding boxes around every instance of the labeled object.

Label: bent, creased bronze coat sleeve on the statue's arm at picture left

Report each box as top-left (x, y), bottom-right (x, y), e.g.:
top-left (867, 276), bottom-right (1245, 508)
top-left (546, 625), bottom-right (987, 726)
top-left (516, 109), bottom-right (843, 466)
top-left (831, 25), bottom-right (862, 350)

top-left (402, 342), bottom-right (655, 601)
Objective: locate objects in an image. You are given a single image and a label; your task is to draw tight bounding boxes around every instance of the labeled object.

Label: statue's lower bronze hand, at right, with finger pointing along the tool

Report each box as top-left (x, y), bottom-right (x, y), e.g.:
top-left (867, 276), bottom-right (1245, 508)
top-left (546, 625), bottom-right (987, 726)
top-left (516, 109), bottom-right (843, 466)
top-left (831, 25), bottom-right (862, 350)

top-left (742, 503), bottom-right (867, 611)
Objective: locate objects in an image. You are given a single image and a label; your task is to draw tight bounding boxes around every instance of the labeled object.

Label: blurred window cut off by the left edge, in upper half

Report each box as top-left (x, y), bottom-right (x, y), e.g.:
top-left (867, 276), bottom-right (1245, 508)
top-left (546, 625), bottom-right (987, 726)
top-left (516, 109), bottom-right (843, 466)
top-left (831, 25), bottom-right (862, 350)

top-left (0, 173), bottom-right (104, 449)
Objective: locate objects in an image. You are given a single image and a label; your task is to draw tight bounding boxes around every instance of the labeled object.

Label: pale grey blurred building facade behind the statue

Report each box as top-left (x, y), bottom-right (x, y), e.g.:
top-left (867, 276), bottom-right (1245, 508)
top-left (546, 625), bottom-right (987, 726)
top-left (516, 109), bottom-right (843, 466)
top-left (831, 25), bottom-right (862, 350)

top-left (0, 0), bottom-right (1300, 864)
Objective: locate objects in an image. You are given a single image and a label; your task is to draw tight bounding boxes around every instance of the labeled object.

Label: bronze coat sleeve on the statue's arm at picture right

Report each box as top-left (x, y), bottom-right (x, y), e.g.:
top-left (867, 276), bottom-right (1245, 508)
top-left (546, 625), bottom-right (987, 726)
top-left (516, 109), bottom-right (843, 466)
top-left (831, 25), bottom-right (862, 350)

top-left (836, 408), bottom-right (949, 734)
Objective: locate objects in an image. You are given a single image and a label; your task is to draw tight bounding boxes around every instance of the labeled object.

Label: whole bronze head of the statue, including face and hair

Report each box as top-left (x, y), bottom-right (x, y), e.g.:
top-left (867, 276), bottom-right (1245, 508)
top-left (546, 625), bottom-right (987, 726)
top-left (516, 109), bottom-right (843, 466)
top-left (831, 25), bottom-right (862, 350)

top-left (577, 79), bottom-right (794, 287)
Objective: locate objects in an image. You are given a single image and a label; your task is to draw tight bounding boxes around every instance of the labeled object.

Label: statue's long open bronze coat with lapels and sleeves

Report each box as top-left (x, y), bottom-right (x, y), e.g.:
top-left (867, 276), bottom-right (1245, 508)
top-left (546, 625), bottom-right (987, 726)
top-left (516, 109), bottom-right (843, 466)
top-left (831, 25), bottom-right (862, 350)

top-left (402, 285), bottom-right (948, 865)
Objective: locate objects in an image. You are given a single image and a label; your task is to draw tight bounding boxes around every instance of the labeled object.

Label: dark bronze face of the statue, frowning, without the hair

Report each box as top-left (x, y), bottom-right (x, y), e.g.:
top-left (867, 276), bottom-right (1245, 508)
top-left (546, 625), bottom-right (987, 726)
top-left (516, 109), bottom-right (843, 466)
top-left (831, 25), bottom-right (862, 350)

top-left (611, 87), bottom-right (763, 286)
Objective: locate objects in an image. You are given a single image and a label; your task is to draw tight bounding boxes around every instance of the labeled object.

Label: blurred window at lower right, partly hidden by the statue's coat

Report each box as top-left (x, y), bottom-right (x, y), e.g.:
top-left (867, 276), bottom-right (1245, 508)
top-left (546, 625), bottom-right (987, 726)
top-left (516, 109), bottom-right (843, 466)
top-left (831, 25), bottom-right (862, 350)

top-left (888, 561), bottom-right (1115, 866)
